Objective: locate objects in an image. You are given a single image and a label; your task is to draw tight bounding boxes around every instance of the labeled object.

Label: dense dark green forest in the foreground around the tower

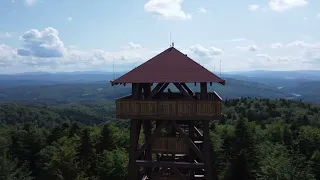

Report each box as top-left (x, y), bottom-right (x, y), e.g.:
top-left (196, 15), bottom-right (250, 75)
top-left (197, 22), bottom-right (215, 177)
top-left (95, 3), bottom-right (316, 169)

top-left (0, 98), bottom-right (320, 180)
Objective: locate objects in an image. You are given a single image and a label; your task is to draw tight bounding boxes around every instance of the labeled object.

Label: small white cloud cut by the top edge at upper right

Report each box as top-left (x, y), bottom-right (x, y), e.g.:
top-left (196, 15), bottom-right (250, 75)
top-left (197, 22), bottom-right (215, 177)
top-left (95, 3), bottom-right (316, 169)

top-left (268, 0), bottom-right (308, 12)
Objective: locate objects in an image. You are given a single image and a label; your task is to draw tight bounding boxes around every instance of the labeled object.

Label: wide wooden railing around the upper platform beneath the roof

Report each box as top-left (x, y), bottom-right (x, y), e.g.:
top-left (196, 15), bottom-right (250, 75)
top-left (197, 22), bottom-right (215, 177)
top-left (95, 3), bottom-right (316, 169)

top-left (116, 98), bottom-right (222, 120)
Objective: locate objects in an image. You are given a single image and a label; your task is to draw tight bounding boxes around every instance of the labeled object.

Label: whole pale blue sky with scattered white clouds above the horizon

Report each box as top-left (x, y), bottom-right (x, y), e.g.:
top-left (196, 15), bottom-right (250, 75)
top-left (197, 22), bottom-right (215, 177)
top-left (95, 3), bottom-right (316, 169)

top-left (0, 0), bottom-right (320, 73)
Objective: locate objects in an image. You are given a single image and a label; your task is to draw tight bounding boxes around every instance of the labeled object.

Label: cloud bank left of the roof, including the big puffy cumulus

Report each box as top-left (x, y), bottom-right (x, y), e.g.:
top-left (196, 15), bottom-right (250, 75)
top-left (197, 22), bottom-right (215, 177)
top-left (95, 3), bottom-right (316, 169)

top-left (0, 27), bottom-right (163, 72)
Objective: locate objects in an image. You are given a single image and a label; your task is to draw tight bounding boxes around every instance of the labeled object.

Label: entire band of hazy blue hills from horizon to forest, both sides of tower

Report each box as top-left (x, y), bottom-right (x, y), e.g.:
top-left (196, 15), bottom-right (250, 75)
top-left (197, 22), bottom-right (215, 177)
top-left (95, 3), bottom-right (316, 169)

top-left (0, 71), bottom-right (320, 104)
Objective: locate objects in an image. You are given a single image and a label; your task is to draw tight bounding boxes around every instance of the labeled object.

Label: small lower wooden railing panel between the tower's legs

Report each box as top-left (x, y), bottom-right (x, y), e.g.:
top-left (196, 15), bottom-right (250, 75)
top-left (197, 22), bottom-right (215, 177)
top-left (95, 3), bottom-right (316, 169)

top-left (152, 137), bottom-right (189, 154)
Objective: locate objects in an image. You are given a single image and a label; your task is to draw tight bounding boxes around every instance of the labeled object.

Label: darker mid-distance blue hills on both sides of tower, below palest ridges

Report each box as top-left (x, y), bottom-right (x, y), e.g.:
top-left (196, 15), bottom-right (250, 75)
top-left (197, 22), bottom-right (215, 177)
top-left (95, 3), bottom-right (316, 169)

top-left (0, 78), bottom-right (304, 105)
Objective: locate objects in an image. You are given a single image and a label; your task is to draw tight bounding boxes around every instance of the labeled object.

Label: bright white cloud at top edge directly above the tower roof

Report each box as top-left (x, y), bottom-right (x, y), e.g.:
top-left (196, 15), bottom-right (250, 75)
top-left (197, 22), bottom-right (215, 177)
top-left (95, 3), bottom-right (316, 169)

top-left (144, 0), bottom-right (191, 20)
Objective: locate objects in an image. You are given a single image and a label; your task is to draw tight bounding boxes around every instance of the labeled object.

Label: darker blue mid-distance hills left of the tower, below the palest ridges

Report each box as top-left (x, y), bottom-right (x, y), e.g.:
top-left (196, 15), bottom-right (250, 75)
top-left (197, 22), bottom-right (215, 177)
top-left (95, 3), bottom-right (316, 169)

top-left (0, 82), bottom-right (130, 105)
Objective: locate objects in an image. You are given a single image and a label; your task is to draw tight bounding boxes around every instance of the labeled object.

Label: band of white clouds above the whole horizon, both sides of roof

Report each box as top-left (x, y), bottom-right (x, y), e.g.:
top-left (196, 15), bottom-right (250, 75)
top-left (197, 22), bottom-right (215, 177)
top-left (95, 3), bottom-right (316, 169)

top-left (0, 28), bottom-right (320, 73)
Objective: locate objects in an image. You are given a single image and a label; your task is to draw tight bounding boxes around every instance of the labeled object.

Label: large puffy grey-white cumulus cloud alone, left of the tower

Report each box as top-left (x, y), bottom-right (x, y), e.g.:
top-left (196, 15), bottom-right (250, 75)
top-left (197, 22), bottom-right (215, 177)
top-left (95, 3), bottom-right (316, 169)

top-left (18, 27), bottom-right (65, 58)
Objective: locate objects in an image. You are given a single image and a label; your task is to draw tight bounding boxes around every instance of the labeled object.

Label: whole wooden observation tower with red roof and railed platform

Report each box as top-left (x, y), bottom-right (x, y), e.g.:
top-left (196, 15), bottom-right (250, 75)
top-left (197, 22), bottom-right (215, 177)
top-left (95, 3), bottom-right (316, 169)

top-left (111, 47), bottom-right (225, 180)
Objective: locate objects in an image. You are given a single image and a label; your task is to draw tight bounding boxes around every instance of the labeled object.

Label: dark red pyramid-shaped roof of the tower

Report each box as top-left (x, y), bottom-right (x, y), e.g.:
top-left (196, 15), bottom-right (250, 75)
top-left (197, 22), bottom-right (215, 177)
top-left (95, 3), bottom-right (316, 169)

top-left (111, 47), bottom-right (225, 85)
